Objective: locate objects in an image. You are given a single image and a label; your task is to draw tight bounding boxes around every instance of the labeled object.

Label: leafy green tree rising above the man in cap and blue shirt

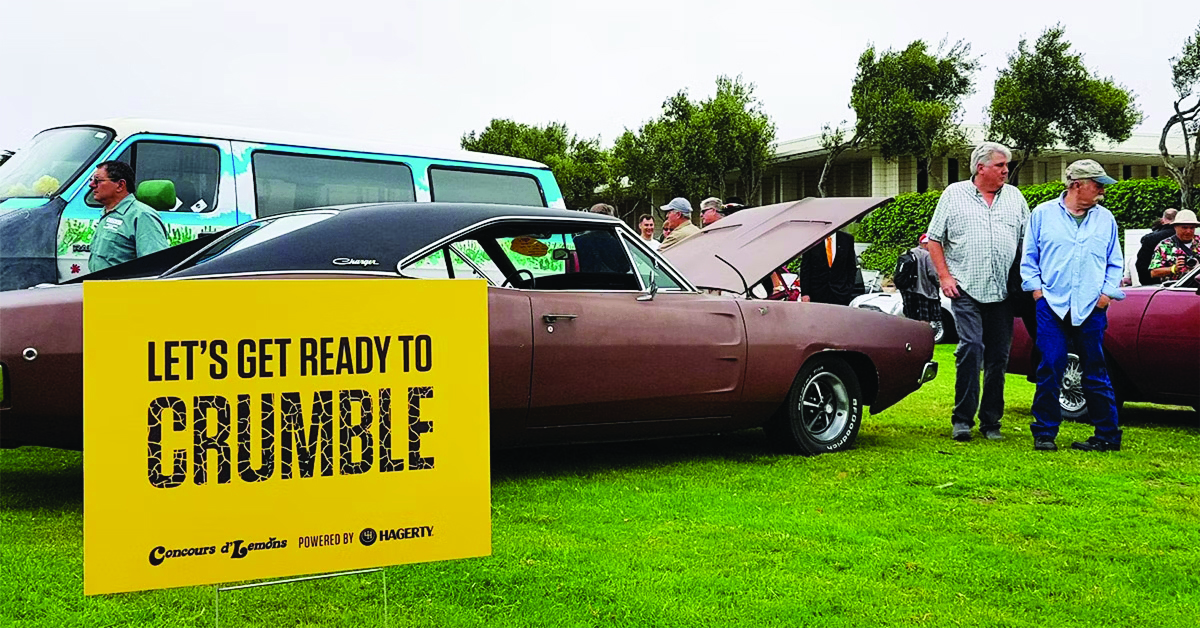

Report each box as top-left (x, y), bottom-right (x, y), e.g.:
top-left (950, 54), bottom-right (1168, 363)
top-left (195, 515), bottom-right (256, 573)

top-left (988, 25), bottom-right (1142, 181)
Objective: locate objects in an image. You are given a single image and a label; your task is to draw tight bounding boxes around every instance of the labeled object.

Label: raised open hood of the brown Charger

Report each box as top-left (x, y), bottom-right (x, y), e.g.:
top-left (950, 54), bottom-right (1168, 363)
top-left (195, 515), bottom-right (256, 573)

top-left (662, 197), bottom-right (890, 294)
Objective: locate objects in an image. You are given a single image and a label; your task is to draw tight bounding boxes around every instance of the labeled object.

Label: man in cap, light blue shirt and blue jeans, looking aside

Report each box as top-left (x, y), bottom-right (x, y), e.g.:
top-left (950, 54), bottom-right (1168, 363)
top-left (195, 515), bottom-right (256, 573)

top-left (1021, 160), bottom-right (1124, 451)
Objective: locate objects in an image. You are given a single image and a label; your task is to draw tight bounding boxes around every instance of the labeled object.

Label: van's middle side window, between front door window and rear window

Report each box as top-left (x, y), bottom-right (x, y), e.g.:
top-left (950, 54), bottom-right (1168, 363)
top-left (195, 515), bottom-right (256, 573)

top-left (251, 152), bottom-right (416, 217)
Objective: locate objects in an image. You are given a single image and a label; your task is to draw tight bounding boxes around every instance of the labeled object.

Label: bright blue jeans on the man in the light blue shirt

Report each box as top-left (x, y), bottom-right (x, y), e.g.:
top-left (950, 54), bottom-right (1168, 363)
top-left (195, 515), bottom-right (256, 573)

top-left (1031, 299), bottom-right (1121, 443)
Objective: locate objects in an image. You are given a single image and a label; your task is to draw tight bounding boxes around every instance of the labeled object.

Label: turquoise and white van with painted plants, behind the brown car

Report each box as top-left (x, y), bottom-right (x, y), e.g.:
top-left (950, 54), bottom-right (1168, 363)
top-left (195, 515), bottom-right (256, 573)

top-left (0, 119), bottom-right (565, 289)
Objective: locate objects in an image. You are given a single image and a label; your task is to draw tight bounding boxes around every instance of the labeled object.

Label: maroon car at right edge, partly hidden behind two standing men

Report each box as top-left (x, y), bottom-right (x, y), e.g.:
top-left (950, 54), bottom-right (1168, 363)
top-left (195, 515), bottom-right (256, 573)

top-left (1008, 268), bottom-right (1200, 419)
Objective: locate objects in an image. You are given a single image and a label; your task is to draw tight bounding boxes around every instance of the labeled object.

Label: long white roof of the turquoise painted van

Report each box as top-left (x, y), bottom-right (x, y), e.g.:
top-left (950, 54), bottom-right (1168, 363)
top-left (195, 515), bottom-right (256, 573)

top-left (64, 118), bottom-right (548, 169)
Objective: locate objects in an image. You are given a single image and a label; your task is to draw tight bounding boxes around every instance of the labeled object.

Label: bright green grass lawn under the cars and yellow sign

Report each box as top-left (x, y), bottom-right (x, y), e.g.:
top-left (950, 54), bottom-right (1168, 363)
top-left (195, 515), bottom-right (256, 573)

top-left (0, 346), bottom-right (1200, 628)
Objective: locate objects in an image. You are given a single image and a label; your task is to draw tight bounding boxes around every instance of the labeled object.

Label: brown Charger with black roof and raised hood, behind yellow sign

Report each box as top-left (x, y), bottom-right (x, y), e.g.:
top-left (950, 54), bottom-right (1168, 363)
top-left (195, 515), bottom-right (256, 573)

top-left (0, 198), bottom-right (937, 454)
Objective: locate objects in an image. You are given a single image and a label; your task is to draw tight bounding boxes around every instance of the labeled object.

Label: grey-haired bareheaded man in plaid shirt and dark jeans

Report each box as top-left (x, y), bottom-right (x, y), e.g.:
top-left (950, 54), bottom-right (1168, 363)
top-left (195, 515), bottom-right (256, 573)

top-left (929, 142), bottom-right (1030, 441)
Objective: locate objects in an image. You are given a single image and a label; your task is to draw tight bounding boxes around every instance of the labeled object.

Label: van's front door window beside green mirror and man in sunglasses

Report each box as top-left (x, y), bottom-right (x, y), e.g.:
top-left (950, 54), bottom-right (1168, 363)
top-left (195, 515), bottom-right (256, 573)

top-left (86, 140), bottom-right (221, 213)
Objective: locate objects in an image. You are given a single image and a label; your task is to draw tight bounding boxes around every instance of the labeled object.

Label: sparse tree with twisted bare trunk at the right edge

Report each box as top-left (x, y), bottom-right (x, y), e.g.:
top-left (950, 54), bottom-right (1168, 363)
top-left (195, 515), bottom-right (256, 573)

top-left (1158, 25), bottom-right (1200, 209)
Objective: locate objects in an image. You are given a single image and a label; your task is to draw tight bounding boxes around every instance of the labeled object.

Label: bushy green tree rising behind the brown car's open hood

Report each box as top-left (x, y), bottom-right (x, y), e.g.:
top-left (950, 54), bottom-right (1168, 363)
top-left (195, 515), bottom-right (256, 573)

top-left (612, 77), bottom-right (775, 205)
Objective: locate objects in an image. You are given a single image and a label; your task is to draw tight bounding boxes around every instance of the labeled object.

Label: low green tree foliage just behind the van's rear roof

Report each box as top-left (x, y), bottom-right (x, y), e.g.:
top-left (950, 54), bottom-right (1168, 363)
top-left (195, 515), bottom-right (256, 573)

top-left (461, 119), bottom-right (608, 209)
